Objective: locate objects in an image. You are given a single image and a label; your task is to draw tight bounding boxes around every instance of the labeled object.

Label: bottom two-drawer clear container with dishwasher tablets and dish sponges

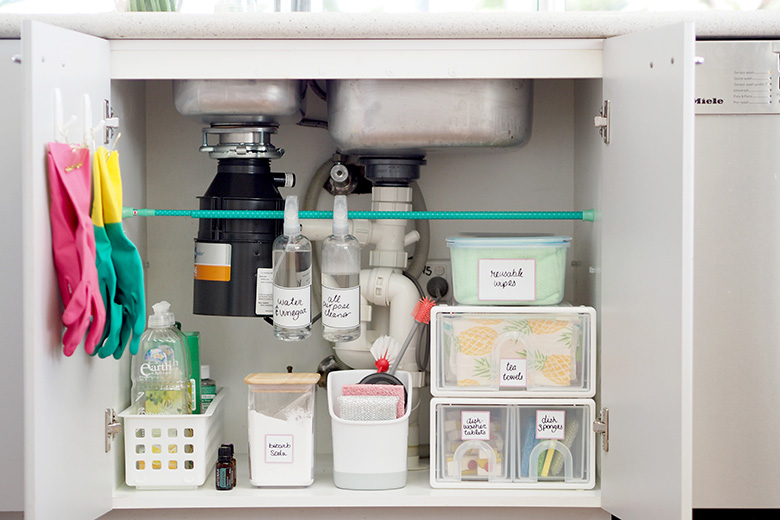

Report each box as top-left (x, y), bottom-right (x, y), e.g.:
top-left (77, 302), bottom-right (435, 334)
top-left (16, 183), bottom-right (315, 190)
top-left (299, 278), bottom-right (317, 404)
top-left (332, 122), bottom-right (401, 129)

top-left (430, 397), bottom-right (596, 489)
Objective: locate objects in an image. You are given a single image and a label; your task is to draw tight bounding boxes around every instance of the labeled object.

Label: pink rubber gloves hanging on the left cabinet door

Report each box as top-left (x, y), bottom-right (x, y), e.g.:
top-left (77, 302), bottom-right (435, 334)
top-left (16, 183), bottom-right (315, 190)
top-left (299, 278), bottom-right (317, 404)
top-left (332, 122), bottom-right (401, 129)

top-left (48, 143), bottom-right (106, 356)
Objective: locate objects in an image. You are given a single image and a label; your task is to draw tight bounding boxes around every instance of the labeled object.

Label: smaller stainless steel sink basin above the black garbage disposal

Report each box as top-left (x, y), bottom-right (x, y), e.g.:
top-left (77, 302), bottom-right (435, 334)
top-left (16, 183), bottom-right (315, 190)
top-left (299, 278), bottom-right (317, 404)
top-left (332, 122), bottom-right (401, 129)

top-left (173, 80), bottom-right (305, 123)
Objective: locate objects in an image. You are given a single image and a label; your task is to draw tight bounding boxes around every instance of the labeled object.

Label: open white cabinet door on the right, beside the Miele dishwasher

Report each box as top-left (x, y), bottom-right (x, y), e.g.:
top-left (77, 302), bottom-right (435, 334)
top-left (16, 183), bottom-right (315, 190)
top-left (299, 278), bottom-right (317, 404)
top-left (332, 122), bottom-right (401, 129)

top-left (601, 24), bottom-right (695, 520)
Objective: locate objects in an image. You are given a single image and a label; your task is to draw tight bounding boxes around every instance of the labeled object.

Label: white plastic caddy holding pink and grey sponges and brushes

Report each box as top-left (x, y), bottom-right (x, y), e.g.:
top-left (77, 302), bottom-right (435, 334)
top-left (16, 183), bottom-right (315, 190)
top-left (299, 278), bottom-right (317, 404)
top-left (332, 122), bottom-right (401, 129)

top-left (328, 370), bottom-right (413, 489)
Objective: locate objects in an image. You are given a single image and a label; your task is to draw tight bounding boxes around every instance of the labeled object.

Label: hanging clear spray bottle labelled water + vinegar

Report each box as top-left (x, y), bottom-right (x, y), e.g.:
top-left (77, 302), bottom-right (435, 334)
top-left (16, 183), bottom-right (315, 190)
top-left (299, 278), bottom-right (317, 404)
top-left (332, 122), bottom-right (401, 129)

top-left (272, 195), bottom-right (312, 341)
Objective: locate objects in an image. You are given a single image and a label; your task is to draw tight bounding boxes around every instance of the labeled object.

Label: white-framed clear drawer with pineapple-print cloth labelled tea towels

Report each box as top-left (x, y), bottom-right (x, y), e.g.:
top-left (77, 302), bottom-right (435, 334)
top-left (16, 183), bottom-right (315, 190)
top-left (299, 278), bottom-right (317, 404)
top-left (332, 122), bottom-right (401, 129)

top-left (431, 306), bottom-right (596, 397)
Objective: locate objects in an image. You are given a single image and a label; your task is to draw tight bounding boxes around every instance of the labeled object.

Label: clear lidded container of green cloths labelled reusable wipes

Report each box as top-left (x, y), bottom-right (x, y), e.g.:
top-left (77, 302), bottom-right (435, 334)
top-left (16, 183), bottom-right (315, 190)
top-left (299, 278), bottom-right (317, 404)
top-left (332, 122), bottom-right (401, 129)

top-left (447, 235), bottom-right (571, 305)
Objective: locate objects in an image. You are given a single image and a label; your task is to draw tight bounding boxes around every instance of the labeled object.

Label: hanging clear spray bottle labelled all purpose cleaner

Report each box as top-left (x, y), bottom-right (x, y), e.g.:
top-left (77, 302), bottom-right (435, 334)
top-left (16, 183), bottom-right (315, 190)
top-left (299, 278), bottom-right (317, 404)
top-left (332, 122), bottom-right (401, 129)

top-left (322, 195), bottom-right (360, 342)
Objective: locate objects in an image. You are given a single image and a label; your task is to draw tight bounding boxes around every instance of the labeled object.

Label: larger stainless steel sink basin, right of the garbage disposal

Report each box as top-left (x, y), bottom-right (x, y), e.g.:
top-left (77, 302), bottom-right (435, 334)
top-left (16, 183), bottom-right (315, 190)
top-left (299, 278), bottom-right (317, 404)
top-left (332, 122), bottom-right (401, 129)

top-left (328, 79), bottom-right (533, 155)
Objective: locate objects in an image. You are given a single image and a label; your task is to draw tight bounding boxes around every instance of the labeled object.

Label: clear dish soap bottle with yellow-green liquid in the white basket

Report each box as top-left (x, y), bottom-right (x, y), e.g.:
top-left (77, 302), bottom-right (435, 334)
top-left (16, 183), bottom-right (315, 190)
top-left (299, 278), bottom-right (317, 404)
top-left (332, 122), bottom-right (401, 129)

top-left (130, 301), bottom-right (192, 415)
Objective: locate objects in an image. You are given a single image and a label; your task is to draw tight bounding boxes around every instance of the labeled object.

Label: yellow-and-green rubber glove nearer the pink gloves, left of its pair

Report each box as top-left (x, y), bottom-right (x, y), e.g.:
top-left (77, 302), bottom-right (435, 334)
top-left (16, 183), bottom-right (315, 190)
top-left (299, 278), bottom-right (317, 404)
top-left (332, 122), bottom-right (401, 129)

top-left (92, 146), bottom-right (122, 358)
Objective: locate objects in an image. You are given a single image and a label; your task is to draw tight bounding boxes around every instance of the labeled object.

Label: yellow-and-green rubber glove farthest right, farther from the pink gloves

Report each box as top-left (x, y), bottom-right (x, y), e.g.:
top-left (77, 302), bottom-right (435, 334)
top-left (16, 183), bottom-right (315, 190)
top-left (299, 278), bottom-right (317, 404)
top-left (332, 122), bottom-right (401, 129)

top-left (100, 146), bottom-right (146, 359)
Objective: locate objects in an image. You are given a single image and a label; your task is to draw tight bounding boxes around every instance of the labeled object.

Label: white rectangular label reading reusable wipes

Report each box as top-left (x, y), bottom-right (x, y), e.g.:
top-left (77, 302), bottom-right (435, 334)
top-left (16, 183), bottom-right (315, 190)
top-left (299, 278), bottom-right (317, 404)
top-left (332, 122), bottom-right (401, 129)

top-left (477, 258), bottom-right (536, 301)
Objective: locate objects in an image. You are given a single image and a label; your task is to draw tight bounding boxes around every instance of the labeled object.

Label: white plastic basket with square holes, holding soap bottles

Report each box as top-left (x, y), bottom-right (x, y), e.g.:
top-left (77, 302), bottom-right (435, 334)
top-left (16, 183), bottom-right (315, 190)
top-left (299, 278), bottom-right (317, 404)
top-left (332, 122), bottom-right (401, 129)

top-left (119, 389), bottom-right (225, 489)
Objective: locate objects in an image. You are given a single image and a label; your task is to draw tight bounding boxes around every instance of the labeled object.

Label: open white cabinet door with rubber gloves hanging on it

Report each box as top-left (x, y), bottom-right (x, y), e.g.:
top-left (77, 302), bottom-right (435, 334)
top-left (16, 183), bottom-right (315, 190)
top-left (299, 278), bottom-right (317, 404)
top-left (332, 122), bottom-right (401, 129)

top-left (22, 21), bottom-right (116, 520)
